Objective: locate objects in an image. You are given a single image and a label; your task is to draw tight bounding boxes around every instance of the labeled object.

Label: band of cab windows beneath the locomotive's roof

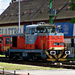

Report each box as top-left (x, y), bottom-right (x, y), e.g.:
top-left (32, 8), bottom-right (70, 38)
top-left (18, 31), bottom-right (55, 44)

top-left (26, 25), bottom-right (55, 34)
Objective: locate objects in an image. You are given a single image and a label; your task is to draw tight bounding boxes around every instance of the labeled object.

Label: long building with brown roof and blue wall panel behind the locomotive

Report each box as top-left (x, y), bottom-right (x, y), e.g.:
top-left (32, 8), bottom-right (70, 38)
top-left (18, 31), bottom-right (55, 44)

top-left (0, 0), bottom-right (75, 49)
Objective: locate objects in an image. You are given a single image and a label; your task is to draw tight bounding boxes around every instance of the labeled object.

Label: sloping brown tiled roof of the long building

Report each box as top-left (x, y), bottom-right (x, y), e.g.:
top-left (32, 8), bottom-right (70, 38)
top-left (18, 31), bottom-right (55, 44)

top-left (0, 0), bottom-right (75, 24)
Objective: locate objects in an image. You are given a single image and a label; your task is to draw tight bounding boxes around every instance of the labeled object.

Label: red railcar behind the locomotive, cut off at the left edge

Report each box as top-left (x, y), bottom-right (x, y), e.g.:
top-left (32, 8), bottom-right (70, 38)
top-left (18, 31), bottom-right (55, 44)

top-left (0, 34), bottom-right (12, 54)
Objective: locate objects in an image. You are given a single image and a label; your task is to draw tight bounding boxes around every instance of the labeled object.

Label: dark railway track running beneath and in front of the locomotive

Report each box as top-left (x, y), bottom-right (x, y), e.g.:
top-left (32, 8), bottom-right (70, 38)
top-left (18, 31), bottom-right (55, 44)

top-left (0, 57), bottom-right (75, 69)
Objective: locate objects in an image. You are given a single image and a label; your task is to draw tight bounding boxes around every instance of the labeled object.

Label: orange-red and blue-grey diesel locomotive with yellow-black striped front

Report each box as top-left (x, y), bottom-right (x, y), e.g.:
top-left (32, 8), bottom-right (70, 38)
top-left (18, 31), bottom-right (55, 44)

top-left (7, 24), bottom-right (70, 61)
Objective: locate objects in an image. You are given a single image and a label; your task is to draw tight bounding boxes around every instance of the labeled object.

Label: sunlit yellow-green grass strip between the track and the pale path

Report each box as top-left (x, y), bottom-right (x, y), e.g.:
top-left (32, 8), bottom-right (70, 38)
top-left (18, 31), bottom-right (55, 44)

top-left (0, 62), bottom-right (61, 70)
